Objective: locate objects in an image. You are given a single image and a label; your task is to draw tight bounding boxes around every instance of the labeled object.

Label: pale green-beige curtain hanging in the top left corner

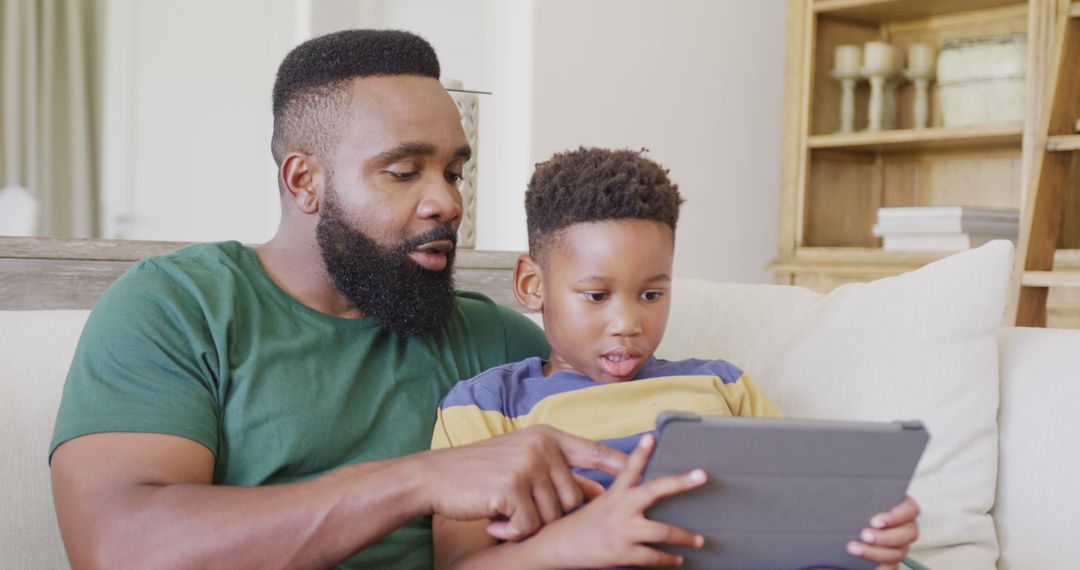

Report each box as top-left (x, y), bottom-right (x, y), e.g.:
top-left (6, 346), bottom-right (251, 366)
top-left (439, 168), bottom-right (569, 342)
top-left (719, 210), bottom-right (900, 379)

top-left (0, 0), bottom-right (104, 238)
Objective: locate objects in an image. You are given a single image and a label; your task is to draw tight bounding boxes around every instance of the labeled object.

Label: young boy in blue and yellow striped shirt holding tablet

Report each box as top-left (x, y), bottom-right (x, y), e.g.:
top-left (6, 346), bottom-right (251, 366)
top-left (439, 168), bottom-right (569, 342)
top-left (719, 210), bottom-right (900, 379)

top-left (432, 148), bottom-right (917, 568)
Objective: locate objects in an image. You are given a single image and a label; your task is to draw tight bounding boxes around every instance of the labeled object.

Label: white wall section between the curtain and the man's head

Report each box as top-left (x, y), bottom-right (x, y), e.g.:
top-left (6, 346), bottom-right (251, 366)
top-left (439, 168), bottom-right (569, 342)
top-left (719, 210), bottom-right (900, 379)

top-left (103, 0), bottom-right (296, 241)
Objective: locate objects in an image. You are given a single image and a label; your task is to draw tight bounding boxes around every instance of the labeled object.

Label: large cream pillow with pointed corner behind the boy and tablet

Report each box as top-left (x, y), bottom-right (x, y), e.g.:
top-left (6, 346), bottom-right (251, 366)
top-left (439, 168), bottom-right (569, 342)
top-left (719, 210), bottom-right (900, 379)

top-left (658, 242), bottom-right (1012, 568)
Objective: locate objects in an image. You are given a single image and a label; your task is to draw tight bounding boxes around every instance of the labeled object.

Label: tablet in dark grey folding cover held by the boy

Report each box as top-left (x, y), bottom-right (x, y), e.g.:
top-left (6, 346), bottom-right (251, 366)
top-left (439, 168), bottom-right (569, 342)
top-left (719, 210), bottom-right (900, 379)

top-left (645, 411), bottom-right (929, 570)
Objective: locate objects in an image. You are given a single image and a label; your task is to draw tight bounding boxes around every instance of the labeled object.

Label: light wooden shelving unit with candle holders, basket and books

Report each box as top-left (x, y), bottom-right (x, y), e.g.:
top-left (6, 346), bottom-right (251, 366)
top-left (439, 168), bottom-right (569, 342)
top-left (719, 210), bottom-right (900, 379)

top-left (769, 0), bottom-right (1080, 326)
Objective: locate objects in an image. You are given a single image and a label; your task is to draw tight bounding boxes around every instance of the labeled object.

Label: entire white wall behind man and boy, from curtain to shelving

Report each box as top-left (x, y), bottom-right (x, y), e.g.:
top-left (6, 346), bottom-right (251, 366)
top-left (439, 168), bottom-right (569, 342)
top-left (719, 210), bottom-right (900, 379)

top-left (103, 0), bottom-right (785, 282)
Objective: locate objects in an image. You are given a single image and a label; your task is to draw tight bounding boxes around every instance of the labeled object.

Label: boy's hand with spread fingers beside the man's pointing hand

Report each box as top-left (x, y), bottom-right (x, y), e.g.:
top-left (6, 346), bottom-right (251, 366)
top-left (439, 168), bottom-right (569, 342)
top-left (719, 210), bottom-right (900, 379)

top-left (524, 434), bottom-right (705, 568)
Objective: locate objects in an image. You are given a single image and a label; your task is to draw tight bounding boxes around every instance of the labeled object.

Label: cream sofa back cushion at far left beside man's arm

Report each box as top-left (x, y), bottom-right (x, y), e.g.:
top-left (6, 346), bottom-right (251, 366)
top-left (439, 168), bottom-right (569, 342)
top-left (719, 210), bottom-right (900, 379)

top-left (0, 311), bottom-right (90, 569)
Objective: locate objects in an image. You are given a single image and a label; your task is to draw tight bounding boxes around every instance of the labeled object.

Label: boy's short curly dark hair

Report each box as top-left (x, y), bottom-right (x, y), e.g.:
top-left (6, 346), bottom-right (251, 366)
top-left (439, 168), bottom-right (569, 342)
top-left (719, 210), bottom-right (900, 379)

top-left (525, 147), bottom-right (683, 259)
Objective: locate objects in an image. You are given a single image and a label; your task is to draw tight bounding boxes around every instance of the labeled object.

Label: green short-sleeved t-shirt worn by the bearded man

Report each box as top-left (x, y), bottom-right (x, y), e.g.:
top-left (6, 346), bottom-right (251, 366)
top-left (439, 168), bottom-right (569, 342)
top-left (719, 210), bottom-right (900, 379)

top-left (52, 242), bottom-right (549, 568)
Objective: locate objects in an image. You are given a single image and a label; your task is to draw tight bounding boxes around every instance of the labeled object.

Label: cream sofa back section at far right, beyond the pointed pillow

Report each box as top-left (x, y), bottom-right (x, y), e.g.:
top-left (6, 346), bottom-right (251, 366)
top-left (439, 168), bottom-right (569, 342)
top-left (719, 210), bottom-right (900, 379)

top-left (994, 328), bottom-right (1080, 570)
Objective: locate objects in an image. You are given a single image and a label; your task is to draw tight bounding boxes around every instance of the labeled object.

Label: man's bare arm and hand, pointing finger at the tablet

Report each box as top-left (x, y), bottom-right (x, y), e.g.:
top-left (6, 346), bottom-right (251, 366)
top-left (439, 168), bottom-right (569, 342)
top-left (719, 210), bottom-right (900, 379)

top-left (52, 428), bottom-right (625, 568)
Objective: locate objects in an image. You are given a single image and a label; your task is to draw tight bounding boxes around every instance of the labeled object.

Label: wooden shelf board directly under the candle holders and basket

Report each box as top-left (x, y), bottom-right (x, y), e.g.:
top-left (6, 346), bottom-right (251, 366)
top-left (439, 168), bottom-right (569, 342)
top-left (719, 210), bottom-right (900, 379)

top-left (807, 123), bottom-right (1024, 151)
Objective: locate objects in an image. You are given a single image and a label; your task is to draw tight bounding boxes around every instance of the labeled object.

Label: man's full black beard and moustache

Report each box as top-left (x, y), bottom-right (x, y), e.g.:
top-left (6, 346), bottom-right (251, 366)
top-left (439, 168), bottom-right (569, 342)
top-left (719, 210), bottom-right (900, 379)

top-left (315, 189), bottom-right (458, 337)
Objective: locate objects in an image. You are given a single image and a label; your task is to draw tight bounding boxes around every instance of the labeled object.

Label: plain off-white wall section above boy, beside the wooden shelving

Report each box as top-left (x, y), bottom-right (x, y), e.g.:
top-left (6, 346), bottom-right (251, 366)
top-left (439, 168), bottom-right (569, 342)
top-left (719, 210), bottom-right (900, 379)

top-left (532, 0), bottom-right (786, 282)
